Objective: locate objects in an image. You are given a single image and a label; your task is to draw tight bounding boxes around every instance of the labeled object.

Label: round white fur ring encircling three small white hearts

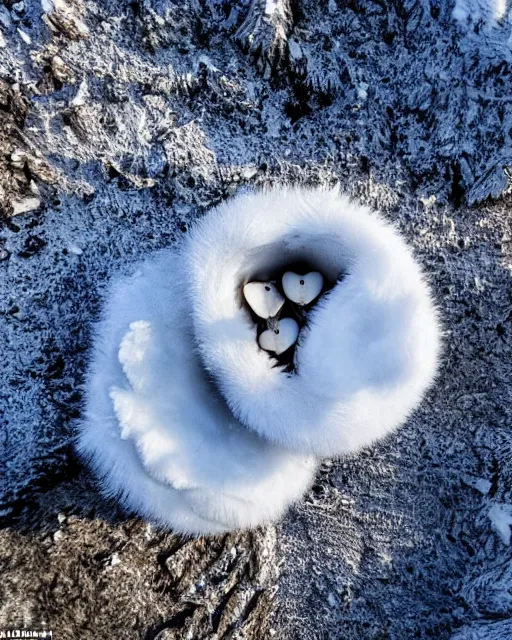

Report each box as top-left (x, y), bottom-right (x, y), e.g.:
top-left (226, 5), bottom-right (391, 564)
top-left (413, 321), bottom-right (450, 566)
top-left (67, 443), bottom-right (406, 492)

top-left (186, 189), bottom-right (440, 456)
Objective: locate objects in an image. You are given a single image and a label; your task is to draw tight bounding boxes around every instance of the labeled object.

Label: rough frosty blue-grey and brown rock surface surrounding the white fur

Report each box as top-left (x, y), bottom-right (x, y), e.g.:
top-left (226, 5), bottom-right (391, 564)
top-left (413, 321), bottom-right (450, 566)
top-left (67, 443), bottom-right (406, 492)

top-left (0, 0), bottom-right (512, 640)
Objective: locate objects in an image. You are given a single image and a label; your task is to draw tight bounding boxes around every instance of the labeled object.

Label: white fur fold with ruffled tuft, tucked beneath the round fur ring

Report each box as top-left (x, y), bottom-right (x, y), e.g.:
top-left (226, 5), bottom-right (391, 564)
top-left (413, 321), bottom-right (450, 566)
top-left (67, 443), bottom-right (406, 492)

top-left (76, 251), bottom-right (316, 534)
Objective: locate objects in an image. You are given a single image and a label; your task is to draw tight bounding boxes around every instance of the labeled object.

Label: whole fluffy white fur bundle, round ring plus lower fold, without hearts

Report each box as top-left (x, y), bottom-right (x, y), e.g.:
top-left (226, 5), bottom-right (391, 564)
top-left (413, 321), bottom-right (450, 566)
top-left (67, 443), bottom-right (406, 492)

top-left (76, 189), bottom-right (439, 534)
